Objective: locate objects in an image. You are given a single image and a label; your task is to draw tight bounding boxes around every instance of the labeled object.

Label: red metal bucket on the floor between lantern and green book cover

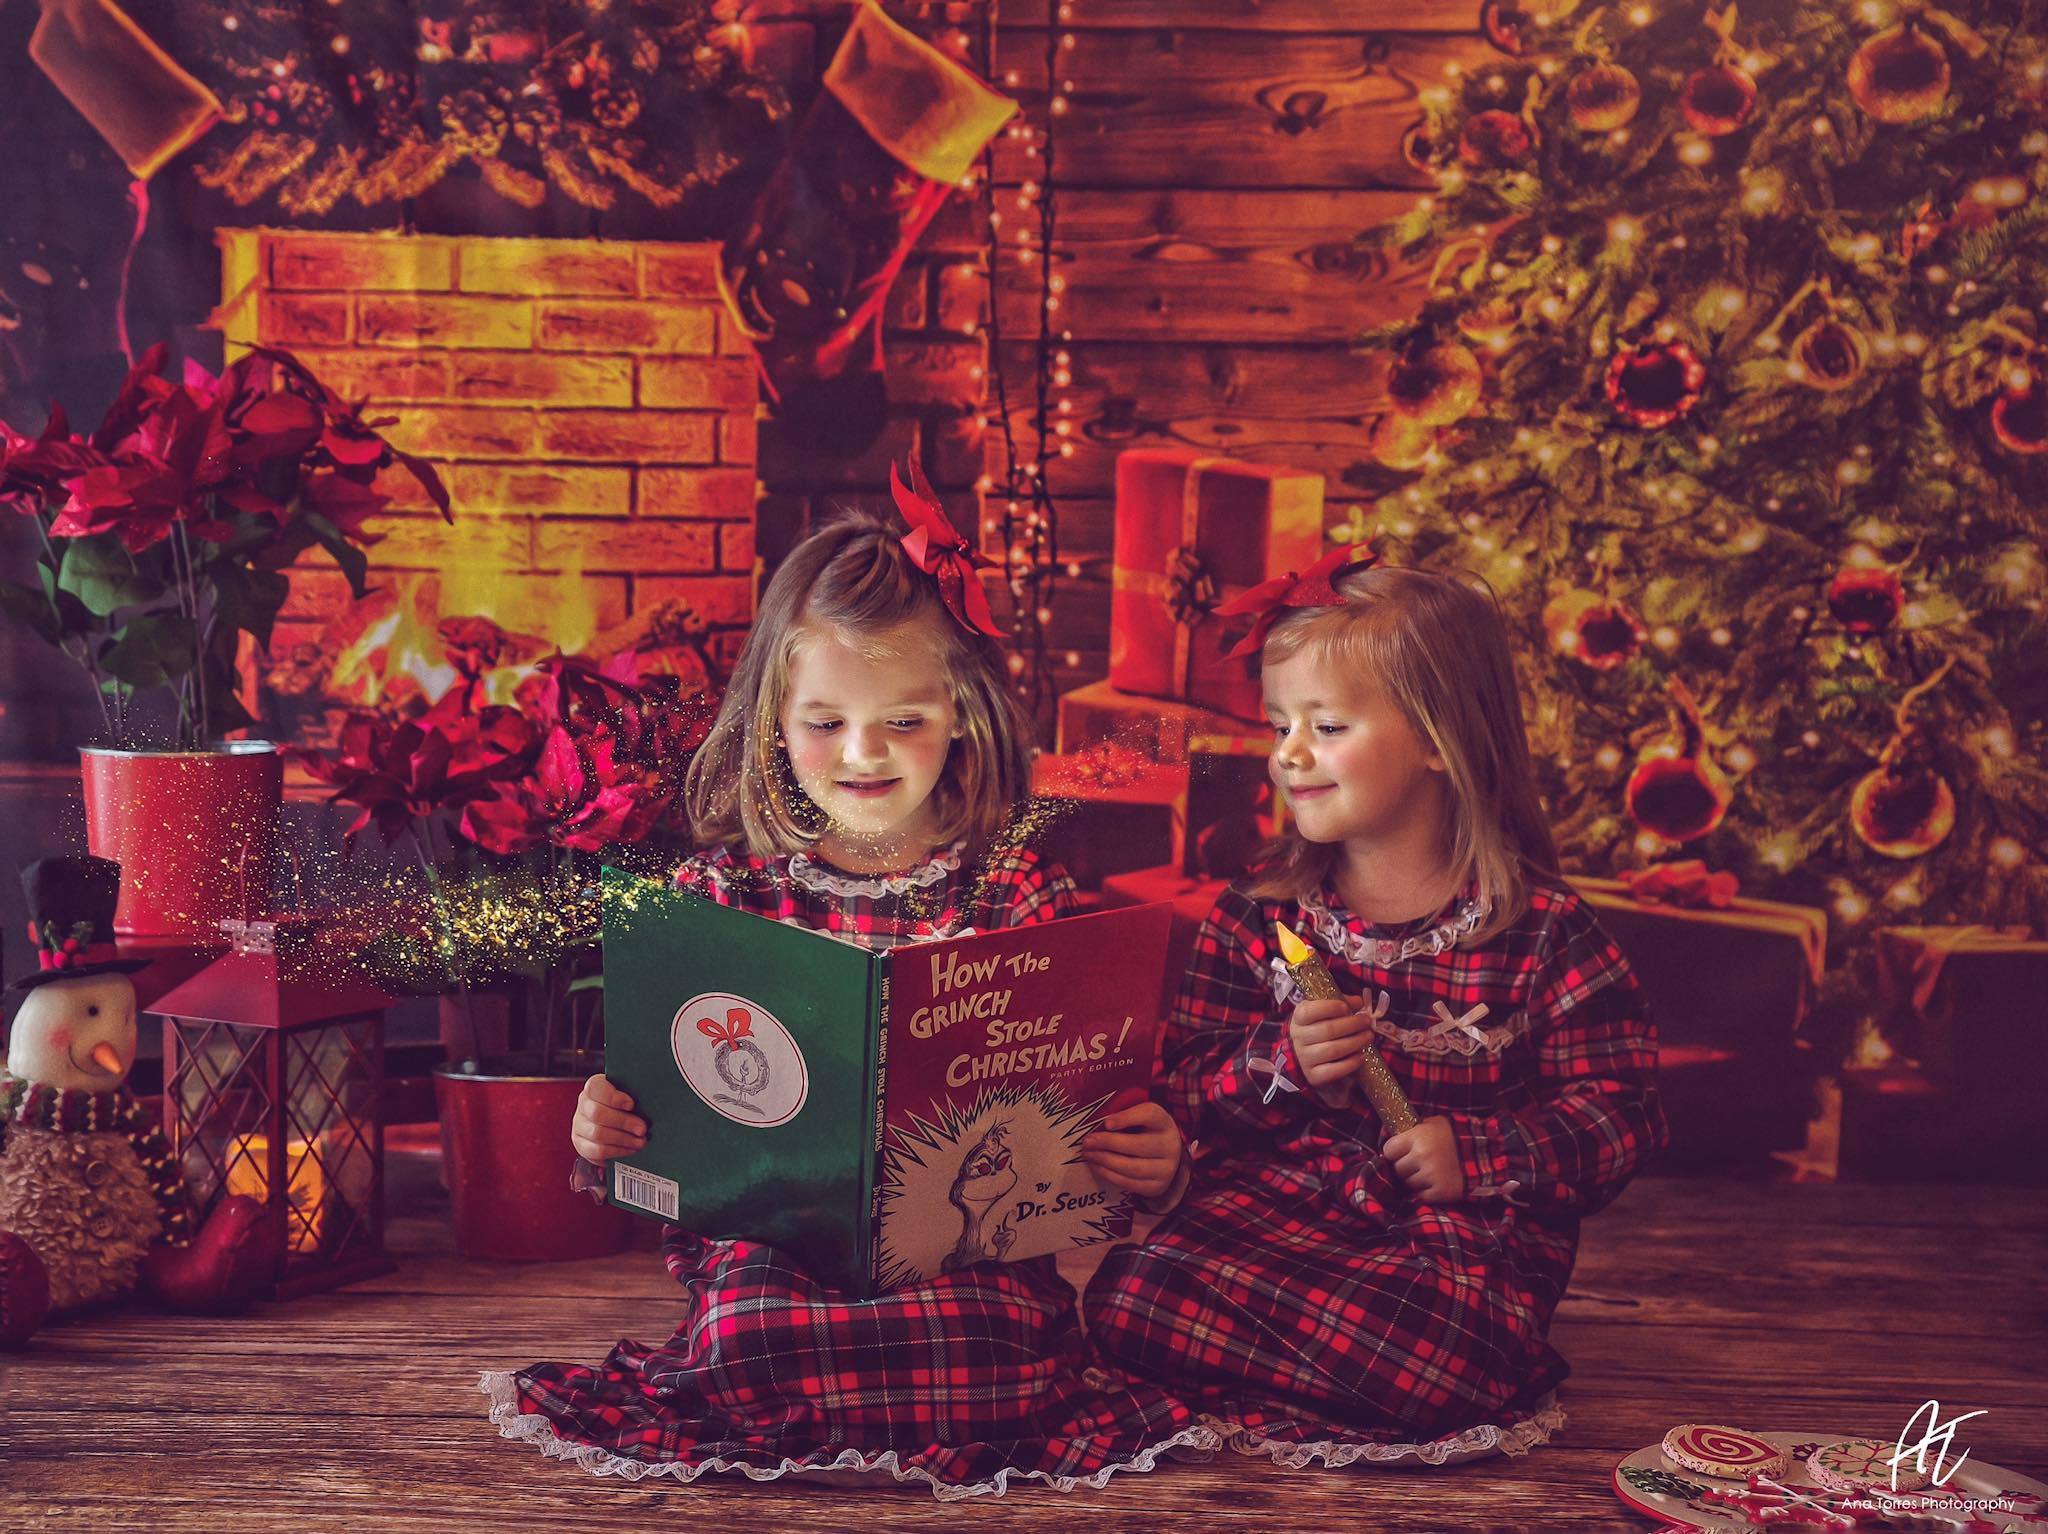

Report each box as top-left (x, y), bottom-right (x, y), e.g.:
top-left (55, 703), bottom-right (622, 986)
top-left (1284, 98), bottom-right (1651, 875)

top-left (434, 1061), bottom-right (635, 1262)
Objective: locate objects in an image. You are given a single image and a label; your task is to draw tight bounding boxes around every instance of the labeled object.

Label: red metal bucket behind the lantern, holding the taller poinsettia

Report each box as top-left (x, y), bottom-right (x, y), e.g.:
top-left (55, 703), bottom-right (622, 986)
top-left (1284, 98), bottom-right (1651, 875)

top-left (78, 741), bottom-right (285, 938)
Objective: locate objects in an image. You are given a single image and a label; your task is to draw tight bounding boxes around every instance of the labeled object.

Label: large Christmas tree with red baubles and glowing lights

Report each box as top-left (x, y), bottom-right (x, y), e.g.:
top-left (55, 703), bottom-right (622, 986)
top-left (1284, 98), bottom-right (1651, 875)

top-left (1354, 0), bottom-right (2048, 1028)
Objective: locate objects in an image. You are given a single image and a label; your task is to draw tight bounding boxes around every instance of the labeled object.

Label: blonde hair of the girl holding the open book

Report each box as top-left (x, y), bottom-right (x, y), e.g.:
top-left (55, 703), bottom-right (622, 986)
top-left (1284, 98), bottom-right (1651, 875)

top-left (684, 512), bottom-right (1030, 858)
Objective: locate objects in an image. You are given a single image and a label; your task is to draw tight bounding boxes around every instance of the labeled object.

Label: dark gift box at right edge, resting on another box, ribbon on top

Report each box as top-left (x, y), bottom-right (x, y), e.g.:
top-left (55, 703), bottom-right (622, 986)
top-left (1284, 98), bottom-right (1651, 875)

top-left (1876, 928), bottom-right (2048, 1090)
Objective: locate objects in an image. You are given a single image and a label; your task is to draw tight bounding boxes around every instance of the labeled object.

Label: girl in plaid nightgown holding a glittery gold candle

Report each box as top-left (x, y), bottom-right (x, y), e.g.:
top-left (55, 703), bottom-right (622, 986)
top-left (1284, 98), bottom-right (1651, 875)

top-left (1083, 551), bottom-right (1665, 1466)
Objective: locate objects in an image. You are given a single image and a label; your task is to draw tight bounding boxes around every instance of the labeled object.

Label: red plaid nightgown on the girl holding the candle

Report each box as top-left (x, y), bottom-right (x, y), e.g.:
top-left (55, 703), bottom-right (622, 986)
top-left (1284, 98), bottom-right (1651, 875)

top-left (1083, 883), bottom-right (1665, 1464)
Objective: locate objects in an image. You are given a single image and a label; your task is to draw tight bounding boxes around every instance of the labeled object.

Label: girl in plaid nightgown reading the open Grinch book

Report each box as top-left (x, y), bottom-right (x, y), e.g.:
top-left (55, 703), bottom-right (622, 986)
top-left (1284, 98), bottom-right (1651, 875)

top-left (483, 469), bottom-right (1200, 1497)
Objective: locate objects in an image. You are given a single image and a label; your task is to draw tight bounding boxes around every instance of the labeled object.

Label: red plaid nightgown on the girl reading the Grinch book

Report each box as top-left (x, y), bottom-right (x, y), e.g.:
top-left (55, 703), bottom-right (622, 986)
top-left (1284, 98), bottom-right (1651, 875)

top-left (483, 848), bottom-right (1208, 1497)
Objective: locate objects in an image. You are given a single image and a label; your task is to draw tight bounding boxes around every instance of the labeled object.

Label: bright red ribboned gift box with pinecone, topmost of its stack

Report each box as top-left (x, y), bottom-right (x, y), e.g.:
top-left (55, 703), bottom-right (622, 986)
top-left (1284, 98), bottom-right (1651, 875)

top-left (1110, 449), bottom-right (1323, 719)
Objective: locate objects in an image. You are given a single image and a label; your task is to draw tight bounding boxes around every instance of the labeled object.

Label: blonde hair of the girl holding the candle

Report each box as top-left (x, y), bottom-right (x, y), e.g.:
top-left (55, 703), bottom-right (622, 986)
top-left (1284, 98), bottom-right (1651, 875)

top-left (1249, 565), bottom-right (1556, 944)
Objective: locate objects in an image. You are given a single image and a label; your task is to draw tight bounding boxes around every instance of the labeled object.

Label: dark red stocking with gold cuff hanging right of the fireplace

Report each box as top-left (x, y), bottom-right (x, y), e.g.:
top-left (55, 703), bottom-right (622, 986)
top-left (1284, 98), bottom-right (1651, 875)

top-left (721, 4), bottom-right (1016, 455)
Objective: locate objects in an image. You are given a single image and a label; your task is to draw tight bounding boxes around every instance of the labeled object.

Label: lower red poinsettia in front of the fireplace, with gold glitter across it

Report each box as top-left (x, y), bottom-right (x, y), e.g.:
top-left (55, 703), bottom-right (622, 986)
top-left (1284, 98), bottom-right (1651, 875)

top-left (293, 619), bottom-right (717, 1073)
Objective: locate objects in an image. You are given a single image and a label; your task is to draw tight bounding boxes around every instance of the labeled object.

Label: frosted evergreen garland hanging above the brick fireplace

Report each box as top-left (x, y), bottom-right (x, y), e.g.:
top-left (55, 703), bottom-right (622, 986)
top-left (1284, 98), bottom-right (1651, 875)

top-left (114, 0), bottom-right (788, 217)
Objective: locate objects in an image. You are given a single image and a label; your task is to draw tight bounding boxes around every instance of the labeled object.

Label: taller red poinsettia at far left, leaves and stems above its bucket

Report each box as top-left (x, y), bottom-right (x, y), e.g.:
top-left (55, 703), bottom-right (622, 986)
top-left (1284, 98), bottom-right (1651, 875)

top-left (0, 344), bottom-right (453, 748)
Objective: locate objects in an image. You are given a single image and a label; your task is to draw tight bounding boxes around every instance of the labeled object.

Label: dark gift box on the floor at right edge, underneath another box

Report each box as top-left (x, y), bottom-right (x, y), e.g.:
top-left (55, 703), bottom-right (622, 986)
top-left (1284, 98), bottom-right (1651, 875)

top-left (1837, 1061), bottom-right (2048, 1188)
